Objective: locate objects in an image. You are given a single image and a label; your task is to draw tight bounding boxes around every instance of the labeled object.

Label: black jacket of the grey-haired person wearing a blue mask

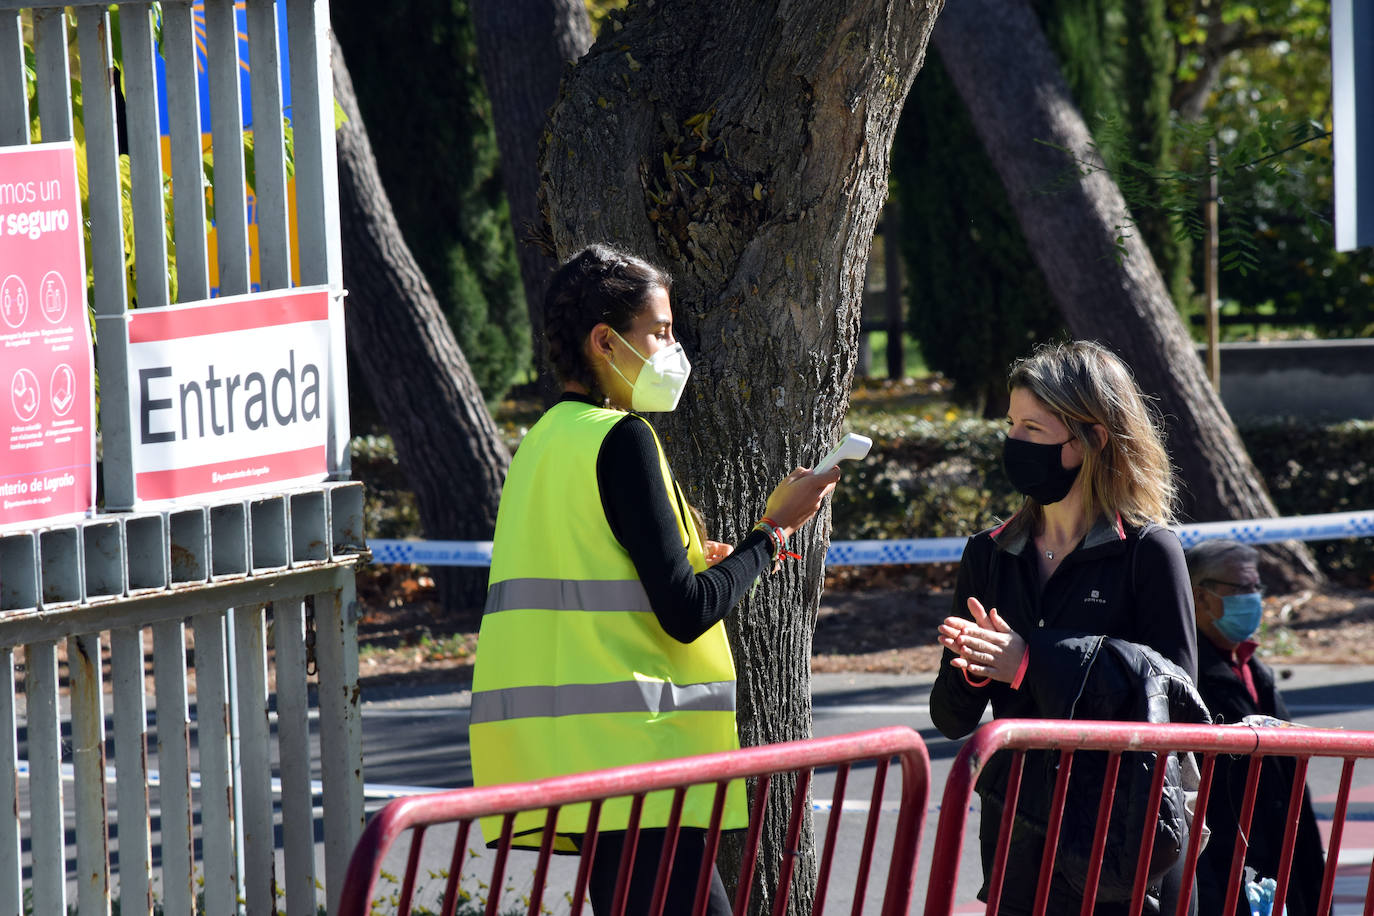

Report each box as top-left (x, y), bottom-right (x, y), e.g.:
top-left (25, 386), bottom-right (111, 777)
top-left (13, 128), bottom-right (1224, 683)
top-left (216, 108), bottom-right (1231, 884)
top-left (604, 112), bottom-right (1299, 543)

top-left (1198, 639), bottom-right (1326, 916)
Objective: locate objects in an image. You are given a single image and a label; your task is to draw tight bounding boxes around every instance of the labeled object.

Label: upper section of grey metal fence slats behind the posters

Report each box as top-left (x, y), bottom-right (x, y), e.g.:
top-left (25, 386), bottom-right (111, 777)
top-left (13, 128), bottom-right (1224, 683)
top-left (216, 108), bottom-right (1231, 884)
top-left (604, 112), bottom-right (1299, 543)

top-left (0, 0), bottom-right (349, 511)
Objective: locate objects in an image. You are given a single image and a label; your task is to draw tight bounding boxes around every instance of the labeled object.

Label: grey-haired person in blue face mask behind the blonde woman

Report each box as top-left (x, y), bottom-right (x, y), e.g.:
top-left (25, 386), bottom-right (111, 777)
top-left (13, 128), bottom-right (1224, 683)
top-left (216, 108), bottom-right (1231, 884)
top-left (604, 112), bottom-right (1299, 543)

top-left (1184, 538), bottom-right (1326, 916)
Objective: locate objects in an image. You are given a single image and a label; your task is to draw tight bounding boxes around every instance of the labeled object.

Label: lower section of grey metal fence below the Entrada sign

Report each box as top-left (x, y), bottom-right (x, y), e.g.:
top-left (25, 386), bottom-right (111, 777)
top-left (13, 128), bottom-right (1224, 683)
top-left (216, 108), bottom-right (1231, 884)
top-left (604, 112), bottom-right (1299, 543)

top-left (0, 483), bottom-right (363, 916)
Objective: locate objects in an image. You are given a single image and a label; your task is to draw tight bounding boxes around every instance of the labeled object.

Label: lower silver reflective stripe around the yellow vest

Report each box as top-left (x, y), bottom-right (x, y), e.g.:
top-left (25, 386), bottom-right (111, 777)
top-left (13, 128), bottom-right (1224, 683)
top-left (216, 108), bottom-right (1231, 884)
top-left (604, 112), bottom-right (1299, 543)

top-left (469, 681), bottom-right (735, 725)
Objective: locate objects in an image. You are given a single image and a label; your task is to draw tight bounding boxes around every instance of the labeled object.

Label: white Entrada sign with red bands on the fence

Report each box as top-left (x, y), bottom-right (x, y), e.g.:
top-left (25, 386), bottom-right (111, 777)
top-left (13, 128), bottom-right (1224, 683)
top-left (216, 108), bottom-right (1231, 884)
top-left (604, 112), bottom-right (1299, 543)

top-left (128, 287), bottom-right (345, 505)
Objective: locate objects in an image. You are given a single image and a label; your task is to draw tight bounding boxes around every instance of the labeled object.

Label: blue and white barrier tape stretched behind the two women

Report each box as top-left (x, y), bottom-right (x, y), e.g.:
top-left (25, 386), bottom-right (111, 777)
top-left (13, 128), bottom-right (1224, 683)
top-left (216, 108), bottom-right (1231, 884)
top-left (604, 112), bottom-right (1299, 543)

top-left (368, 511), bottom-right (1374, 566)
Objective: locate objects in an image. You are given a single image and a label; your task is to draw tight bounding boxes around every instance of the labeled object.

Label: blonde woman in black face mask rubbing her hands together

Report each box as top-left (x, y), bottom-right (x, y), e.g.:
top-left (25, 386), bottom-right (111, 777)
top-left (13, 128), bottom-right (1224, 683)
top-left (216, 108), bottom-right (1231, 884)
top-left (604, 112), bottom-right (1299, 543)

top-left (930, 341), bottom-right (1197, 913)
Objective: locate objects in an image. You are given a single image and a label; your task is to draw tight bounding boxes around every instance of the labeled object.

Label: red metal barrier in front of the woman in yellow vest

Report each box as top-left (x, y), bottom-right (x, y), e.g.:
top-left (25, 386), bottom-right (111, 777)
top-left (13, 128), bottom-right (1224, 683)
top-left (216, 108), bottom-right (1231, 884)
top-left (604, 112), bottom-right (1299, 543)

top-left (339, 728), bottom-right (930, 916)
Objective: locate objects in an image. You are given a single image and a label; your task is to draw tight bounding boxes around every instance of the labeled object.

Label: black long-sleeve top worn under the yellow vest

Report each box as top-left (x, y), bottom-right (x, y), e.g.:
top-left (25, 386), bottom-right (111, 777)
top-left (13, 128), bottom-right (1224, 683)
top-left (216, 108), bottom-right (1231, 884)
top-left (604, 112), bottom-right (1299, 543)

top-left (562, 394), bottom-right (772, 643)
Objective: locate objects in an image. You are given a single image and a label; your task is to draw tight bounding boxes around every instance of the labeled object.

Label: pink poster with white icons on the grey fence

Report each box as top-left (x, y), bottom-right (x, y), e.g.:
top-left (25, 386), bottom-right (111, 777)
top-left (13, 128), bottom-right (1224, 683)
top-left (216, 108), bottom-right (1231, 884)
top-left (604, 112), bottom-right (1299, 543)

top-left (0, 141), bottom-right (95, 529)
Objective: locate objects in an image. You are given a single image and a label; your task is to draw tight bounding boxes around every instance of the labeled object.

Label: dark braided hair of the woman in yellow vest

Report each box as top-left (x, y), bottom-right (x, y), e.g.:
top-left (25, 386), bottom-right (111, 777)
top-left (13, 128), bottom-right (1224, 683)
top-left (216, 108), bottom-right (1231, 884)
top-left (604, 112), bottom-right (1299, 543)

top-left (544, 244), bottom-right (673, 391)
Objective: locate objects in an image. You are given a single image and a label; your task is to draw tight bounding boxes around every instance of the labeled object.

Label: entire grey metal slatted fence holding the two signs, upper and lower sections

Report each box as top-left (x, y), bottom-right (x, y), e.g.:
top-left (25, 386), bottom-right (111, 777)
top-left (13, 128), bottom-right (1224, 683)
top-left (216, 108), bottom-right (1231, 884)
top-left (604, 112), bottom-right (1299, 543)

top-left (0, 0), bottom-right (363, 915)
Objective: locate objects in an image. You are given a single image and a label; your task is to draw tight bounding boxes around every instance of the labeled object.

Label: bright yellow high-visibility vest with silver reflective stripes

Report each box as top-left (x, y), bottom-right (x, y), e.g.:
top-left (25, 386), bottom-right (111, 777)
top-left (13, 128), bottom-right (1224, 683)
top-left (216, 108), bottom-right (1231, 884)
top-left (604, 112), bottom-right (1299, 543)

top-left (469, 401), bottom-right (747, 851)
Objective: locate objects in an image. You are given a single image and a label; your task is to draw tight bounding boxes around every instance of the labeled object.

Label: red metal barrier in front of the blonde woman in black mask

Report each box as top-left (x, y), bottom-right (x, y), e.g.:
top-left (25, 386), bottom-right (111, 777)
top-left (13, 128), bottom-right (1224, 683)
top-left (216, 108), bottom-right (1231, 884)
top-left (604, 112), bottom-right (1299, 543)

top-left (925, 718), bottom-right (1374, 916)
